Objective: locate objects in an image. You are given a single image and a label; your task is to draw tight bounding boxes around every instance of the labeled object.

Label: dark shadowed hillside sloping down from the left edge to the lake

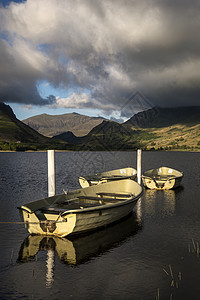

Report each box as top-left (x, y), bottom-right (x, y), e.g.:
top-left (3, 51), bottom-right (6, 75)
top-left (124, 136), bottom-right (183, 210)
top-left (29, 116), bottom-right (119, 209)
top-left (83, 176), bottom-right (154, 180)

top-left (0, 102), bottom-right (69, 150)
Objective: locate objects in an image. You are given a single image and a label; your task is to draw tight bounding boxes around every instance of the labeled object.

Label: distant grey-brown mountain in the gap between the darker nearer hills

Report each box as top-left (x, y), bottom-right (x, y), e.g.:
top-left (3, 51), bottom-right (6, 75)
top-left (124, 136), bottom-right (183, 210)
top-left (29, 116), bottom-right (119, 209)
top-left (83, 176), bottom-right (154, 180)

top-left (23, 113), bottom-right (105, 137)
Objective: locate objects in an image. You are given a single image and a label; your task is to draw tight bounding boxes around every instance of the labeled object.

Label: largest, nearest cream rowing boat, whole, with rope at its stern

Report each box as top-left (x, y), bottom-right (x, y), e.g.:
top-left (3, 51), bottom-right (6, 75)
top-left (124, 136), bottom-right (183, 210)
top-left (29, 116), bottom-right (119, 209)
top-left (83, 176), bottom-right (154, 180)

top-left (19, 179), bottom-right (142, 237)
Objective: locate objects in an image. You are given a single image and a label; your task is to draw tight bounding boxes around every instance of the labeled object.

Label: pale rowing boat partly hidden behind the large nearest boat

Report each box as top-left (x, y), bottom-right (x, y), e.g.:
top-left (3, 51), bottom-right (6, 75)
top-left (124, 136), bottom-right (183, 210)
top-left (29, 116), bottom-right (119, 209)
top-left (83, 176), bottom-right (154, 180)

top-left (79, 167), bottom-right (137, 188)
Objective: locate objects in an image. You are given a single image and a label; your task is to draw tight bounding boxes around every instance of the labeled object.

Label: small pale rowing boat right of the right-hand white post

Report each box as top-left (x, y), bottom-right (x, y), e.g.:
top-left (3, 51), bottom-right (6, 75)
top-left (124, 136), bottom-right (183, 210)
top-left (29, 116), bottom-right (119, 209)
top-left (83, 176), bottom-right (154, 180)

top-left (142, 167), bottom-right (183, 190)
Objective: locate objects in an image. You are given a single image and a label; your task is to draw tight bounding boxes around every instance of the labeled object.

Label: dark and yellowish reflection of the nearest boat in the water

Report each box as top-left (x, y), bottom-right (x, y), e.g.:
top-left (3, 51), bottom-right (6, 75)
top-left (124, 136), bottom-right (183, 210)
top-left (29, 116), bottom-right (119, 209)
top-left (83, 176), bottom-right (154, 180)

top-left (18, 213), bottom-right (142, 273)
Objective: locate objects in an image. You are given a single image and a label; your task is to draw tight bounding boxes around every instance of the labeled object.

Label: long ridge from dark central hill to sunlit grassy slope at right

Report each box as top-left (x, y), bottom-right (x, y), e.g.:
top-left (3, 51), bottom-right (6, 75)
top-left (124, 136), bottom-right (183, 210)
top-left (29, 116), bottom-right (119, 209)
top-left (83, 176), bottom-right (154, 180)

top-left (54, 107), bottom-right (200, 151)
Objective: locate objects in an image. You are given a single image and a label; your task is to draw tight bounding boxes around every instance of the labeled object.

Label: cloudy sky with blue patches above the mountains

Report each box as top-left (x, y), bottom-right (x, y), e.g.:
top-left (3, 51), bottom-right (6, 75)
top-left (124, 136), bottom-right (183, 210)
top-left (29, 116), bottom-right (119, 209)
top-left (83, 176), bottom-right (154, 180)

top-left (0, 0), bottom-right (200, 119)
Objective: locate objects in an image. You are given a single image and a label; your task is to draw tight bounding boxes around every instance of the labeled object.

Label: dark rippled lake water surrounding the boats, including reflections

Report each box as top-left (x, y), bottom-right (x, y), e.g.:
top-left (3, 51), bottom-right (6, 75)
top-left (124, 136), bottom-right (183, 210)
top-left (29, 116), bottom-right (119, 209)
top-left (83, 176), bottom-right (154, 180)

top-left (0, 151), bottom-right (200, 300)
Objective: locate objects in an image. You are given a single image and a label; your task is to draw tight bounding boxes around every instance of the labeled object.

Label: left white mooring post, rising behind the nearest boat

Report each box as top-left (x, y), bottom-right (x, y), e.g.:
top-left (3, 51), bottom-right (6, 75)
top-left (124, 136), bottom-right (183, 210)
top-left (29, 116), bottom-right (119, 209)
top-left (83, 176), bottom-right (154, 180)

top-left (47, 150), bottom-right (56, 197)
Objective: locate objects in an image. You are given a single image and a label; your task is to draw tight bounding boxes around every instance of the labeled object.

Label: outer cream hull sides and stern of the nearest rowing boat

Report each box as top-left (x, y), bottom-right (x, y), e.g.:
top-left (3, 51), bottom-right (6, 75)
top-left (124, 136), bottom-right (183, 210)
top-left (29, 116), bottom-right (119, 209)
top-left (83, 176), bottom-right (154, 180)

top-left (21, 199), bottom-right (140, 237)
